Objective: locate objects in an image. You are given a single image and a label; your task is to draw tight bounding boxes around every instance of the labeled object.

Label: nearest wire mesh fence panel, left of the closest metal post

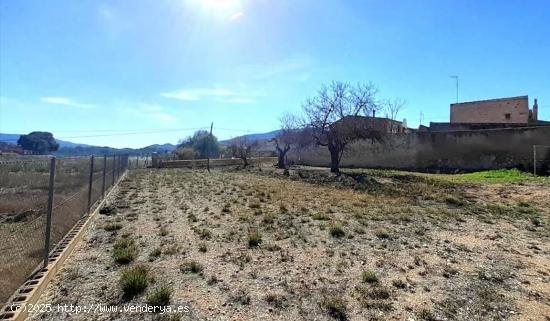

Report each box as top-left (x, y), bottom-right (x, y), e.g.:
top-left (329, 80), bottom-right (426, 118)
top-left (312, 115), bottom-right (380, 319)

top-left (0, 158), bottom-right (50, 306)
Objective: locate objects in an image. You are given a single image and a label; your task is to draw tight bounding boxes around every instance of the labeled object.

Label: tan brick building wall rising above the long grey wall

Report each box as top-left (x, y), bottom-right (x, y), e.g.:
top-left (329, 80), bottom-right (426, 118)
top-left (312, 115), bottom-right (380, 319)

top-left (451, 96), bottom-right (529, 124)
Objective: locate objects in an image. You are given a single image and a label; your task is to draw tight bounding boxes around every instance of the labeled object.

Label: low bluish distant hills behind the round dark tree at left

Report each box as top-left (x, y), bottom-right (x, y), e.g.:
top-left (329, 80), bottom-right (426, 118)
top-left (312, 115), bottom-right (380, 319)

top-left (0, 133), bottom-right (176, 156)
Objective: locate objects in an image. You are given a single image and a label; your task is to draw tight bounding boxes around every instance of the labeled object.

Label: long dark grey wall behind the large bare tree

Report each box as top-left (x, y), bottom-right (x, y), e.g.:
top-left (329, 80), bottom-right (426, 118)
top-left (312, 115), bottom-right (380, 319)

top-left (288, 127), bottom-right (550, 172)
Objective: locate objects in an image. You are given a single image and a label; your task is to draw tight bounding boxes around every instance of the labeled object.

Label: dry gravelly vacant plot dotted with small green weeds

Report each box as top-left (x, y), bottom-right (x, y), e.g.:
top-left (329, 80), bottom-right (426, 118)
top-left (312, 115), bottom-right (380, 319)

top-left (27, 168), bottom-right (550, 321)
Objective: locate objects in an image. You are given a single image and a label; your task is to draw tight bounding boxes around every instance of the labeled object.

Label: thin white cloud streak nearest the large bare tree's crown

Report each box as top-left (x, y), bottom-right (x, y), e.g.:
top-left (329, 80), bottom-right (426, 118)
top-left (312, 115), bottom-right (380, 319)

top-left (160, 88), bottom-right (255, 104)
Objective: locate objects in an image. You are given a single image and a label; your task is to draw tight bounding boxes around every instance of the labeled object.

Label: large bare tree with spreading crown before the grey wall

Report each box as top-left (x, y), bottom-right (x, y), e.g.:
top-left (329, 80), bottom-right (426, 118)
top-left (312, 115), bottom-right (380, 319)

top-left (302, 81), bottom-right (381, 173)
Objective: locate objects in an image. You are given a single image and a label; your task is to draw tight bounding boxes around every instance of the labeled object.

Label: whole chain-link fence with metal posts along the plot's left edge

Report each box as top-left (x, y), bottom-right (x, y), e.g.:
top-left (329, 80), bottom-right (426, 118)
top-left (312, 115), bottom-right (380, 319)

top-left (0, 155), bottom-right (130, 307)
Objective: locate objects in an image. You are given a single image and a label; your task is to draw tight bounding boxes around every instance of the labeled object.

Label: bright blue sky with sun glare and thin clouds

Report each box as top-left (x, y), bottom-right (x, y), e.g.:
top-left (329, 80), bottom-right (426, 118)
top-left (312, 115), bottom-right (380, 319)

top-left (0, 0), bottom-right (550, 147)
